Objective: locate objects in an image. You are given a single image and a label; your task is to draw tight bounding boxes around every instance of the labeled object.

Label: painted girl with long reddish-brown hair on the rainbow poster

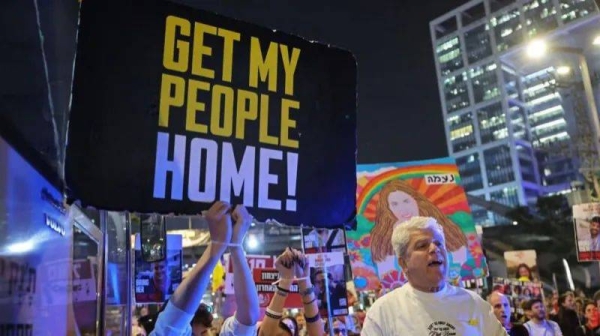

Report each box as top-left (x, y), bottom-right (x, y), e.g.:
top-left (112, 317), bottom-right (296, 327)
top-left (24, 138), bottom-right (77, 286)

top-left (371, 180), bottom-right (468, 279)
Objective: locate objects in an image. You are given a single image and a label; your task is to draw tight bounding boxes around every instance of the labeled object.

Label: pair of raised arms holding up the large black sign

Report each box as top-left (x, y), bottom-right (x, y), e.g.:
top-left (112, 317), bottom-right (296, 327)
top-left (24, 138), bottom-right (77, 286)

top-left (150, 201), bottom-right (259, 336)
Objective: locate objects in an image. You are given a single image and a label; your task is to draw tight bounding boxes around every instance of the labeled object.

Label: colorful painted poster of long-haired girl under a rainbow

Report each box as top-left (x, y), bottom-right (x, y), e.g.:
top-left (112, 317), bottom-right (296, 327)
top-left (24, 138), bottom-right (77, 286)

top-left (346, 158), bottom-right (488, 291)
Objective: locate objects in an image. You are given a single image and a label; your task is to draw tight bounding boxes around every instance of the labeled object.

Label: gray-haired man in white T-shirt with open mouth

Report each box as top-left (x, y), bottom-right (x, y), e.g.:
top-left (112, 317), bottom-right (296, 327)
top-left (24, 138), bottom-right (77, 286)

top-left (361, 217), bottom-right (507, 336)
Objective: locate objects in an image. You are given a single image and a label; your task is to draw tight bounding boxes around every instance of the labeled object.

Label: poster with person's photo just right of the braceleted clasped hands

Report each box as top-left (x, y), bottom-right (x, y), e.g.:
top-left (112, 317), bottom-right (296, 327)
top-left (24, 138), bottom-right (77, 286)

top-left (306, 252), bottom-right (348, 317)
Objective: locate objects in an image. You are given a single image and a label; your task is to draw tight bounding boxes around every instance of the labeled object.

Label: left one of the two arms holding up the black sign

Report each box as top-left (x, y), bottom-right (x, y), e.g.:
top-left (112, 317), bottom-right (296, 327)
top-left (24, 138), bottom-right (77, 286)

top-left (151, 202), bottom-right (231, 336)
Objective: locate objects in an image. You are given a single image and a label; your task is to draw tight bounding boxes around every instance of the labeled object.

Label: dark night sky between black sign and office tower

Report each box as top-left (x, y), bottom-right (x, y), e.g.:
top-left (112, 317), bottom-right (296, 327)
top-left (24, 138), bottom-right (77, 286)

top-left (179, 0), bottom-right (466, 163)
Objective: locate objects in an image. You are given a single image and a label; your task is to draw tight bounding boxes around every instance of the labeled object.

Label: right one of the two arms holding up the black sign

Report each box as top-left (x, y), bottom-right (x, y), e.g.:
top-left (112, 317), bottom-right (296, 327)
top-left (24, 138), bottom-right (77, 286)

top-left (230, 205), bottom-right (259, 326)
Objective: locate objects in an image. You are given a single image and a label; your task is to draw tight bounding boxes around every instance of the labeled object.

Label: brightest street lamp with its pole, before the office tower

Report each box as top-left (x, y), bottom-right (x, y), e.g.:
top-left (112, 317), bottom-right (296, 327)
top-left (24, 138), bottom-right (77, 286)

top-left (527, 39), bottom-right (600, 158)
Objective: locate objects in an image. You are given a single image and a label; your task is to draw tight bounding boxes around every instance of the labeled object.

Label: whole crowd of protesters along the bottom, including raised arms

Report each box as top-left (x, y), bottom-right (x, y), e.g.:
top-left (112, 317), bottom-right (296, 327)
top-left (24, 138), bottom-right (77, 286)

top-left (129, 206), bottom-right (600, 336)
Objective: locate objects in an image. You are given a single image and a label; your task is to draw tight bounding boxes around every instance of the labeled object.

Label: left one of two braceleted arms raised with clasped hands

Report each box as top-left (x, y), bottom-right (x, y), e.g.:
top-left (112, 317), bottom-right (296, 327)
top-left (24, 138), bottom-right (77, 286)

top-left (259, 250), bottom-right (294, 336)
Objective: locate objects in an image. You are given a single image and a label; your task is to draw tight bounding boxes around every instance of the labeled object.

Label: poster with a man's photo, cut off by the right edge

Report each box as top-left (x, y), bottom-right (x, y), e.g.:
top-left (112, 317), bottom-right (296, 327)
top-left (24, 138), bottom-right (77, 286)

top-left (573, 203), bottom-right (600, 261)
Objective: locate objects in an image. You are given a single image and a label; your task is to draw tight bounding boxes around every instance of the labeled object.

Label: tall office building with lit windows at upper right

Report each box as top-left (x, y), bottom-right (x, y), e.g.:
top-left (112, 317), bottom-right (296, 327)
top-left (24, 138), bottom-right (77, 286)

top-left (430, 0), bottom-right (600, 226)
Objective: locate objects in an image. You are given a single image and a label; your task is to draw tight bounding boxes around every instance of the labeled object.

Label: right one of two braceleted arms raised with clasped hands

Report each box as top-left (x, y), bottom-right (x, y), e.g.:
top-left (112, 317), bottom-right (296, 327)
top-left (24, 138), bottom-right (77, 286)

top-left (293, 250), bottom-right (324, 336)
